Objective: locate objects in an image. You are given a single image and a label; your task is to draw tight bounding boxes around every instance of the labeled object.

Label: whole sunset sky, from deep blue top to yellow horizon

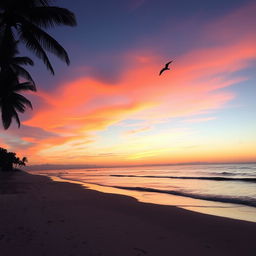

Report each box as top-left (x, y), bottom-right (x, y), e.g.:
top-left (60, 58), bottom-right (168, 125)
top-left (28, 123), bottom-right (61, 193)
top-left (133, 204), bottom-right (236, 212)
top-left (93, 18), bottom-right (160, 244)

top-left (0, 0), bottom-right (256, 166)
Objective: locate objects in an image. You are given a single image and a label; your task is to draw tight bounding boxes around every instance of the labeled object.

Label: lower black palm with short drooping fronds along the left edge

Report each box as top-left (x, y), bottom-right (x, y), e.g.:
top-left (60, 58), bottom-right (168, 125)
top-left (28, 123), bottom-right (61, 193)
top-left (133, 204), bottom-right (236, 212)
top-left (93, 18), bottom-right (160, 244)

top-left (0, 33), bottom-right (36, 129)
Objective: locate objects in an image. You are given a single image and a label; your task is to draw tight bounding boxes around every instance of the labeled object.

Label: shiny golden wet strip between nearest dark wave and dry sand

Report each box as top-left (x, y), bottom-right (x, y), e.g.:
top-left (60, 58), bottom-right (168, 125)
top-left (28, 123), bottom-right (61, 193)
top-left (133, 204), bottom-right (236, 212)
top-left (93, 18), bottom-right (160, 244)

top-left (35, 171), bottom-right (256, 223)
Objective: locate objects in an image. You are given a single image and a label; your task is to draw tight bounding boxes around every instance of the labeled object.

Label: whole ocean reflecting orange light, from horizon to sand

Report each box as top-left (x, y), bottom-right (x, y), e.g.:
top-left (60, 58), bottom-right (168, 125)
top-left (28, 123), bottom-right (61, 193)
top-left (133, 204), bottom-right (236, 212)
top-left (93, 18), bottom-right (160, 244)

top-left (28, 164), bottom-right (256, 222)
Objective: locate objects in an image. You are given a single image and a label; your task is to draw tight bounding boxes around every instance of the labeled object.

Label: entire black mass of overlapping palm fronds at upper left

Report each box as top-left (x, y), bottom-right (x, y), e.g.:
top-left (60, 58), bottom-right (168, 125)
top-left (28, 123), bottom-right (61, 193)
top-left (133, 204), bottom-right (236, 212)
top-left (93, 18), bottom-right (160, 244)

top-left (0, 0), bottom-right (76, 129)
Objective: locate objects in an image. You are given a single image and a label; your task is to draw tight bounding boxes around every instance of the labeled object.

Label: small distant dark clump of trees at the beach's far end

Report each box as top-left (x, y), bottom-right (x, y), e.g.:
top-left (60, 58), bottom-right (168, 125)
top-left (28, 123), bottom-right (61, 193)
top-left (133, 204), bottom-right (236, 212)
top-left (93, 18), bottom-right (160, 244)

top-left (0, 148), bottom-right (28, 172)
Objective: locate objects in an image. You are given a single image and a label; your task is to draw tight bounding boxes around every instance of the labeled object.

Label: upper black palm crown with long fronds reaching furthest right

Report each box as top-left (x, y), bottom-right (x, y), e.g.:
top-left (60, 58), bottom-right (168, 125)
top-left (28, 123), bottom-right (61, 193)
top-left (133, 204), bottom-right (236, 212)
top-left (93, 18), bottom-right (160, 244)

top-left (0, 0), bottom-right (76, 74)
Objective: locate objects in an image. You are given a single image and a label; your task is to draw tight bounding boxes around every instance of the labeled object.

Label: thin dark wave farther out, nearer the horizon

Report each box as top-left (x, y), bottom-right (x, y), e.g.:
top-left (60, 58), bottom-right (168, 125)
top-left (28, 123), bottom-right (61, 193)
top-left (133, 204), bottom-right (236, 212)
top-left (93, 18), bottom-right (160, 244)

top-left (110, 174), bottom-right (256, 183)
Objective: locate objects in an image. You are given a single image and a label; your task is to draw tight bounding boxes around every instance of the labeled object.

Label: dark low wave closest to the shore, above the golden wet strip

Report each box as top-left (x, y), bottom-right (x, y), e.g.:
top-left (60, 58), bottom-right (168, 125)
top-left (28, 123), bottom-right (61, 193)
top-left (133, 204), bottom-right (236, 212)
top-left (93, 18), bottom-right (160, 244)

top-left (114, 186), bottom-right (256, 207)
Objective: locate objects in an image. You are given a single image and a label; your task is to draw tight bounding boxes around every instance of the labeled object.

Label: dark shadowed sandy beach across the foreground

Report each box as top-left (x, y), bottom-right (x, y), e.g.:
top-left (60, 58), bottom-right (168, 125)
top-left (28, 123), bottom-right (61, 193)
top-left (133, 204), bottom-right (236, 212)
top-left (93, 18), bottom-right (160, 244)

top-left (0, 172), bottom-right (256, 256)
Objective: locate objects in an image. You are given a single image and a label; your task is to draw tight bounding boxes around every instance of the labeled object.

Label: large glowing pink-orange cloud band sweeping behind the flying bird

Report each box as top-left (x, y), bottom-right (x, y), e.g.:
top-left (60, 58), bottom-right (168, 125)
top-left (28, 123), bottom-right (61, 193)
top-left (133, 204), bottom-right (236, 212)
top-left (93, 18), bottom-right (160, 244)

top-left (21, 34), bottom-right (256, 160)
